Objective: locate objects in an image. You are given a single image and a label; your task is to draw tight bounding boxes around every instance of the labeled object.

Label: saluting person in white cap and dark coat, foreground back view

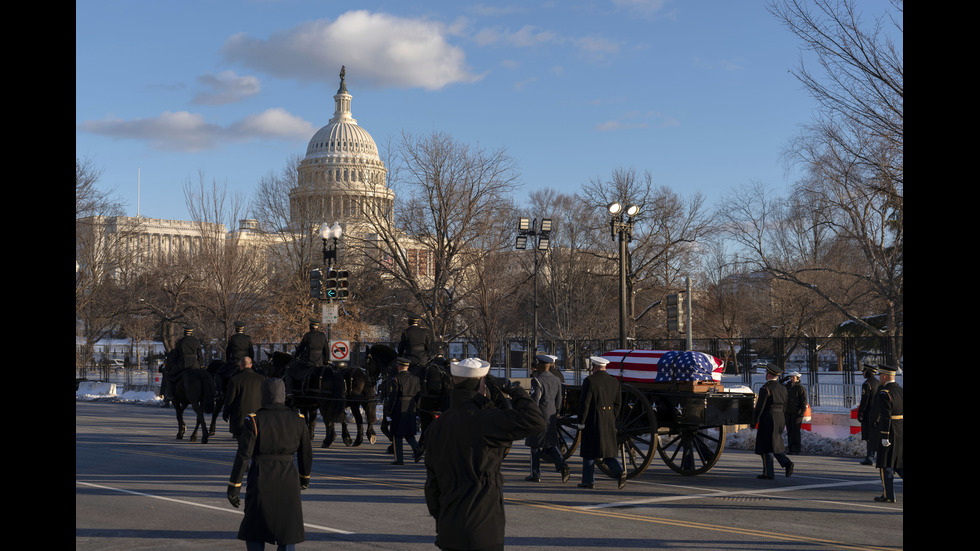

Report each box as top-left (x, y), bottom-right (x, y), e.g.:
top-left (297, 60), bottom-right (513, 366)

top-left (425, 358), bottom-right (545, 550)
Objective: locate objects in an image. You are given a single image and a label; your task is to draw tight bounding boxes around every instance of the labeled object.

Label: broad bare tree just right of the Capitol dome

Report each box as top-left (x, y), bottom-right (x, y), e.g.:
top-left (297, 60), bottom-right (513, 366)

top-left (352, 132), bottom-right (519, 341)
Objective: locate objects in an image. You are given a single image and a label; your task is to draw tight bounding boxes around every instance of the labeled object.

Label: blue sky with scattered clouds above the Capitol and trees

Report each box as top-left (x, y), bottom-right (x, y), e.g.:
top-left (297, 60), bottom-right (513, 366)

top-left (75, 0), bottom-right (868, 223)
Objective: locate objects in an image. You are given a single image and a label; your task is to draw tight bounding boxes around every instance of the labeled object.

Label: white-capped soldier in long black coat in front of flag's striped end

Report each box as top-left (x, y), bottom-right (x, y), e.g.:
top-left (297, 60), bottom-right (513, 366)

top-left (578, 356), bottom-right (626, 489)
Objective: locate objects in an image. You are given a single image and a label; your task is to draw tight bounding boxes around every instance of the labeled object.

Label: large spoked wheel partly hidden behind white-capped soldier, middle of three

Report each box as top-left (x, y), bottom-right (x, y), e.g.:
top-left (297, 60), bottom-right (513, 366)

top-left (595, 384), bottom-right (657, 478)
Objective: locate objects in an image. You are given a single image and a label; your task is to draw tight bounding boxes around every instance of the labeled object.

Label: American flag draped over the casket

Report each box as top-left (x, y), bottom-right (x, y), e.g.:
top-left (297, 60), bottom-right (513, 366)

top-left (602, 350), bottom-right (724, 383)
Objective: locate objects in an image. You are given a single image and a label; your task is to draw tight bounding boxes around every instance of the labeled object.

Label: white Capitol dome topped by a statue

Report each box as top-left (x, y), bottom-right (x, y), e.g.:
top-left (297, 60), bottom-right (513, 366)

top-left (290, 69), bottom-right (394, 230)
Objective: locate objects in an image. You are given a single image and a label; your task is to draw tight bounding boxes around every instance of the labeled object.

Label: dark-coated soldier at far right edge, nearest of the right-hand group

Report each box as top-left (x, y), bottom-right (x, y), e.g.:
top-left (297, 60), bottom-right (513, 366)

top-left (874, 365), bottom-right (905, 503)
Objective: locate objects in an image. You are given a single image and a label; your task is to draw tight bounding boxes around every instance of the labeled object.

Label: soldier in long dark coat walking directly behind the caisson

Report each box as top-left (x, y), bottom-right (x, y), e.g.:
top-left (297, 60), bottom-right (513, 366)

top-left (752, 364), bottom-right (794, 479)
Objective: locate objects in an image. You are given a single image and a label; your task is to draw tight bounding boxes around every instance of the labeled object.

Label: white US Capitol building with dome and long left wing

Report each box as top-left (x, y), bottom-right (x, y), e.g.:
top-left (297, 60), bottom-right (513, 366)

top-left (76, 68), bottom-right (410, 272)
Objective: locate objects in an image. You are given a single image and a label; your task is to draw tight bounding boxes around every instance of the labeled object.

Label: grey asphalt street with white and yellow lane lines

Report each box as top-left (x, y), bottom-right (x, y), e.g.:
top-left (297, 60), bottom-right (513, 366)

top-left (75, 402), bottom-right (904, 551)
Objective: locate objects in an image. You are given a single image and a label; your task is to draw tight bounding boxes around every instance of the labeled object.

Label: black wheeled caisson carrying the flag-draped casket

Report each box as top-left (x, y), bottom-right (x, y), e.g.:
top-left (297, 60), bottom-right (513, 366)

top-left (558, 350), bottom-right (755, 478)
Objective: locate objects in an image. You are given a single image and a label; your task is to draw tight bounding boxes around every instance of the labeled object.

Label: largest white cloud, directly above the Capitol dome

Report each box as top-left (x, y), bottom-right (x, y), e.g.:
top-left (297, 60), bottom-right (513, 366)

top-left (222, 10), bottom-right (480, 90)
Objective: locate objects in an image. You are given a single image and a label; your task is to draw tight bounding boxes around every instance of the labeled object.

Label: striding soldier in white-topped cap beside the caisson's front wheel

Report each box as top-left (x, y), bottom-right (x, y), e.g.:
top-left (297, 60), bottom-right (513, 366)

top-left (524, 354), bottom-right (571, 484)
